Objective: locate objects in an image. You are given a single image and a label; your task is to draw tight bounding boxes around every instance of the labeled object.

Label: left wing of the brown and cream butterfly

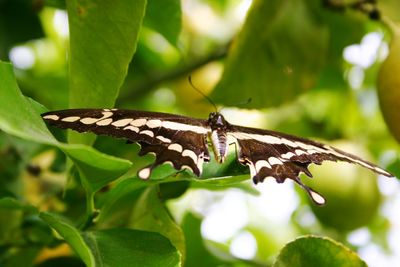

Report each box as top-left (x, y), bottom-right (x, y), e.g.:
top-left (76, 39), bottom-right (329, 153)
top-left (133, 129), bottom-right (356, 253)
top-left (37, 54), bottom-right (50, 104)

top-left (42, 109), bottom-right (210, 179)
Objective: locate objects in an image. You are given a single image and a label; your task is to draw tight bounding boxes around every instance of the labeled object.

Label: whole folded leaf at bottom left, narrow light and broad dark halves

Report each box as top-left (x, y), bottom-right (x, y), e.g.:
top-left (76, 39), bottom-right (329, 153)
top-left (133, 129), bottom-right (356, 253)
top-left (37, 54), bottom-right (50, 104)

top-left (40, 212), bottom-right (180, 267)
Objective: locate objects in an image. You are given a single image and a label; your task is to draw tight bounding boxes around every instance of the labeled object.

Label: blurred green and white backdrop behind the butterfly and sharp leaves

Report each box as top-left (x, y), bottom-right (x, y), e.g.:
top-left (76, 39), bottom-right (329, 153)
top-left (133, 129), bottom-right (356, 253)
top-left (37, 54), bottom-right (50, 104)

top-left (0, 0), bottom-right (400, 267)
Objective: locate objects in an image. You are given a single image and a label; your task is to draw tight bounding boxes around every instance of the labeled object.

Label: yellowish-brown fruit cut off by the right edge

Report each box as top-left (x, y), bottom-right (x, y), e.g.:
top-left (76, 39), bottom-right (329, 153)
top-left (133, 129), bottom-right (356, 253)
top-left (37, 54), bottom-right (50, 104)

top-left (378, 32), bottom-right (400, 142)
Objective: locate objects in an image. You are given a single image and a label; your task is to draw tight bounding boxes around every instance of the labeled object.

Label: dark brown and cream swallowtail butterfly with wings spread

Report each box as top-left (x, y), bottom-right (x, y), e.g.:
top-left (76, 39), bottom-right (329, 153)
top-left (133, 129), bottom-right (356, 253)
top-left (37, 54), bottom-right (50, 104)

top-left (42, 109), bottom-right (392, 205)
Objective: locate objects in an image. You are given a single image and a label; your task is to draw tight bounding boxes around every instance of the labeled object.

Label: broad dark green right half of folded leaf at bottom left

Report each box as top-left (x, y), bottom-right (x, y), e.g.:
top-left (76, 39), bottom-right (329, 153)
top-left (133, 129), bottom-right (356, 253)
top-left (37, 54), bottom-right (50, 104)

top-left (84, 228), bottom-right (181, 267)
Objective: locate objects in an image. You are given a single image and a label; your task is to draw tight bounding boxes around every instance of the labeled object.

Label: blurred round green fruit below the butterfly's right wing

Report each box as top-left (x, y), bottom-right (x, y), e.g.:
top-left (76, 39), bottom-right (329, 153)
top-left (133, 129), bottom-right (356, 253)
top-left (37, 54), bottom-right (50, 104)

top-left (303, 144), bottom-right (381, 232)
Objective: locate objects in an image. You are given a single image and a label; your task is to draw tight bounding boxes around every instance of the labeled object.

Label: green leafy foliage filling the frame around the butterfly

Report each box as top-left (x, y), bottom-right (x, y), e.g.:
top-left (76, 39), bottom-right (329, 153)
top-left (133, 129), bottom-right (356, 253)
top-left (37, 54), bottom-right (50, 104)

top-left (0, 0), bottom-right (400, 267)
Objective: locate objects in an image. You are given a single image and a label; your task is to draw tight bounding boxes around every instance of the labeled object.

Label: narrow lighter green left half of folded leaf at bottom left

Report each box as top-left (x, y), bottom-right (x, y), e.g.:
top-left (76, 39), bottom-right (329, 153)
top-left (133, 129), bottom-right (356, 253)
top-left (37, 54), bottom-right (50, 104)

top-left (39, 212), bottom-right (95, 267)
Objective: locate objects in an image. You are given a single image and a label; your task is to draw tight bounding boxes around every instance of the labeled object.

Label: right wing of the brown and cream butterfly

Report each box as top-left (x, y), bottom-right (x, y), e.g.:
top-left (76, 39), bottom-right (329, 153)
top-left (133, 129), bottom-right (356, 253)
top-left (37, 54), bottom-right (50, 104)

top-left (228, 125), bottom-right (393, 204)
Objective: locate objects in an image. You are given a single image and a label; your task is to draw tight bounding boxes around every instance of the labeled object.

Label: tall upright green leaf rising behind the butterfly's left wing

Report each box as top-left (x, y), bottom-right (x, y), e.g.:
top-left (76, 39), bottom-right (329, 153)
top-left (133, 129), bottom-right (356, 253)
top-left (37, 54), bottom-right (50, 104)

top-left (67, 0), bottom-right (146, 143)
